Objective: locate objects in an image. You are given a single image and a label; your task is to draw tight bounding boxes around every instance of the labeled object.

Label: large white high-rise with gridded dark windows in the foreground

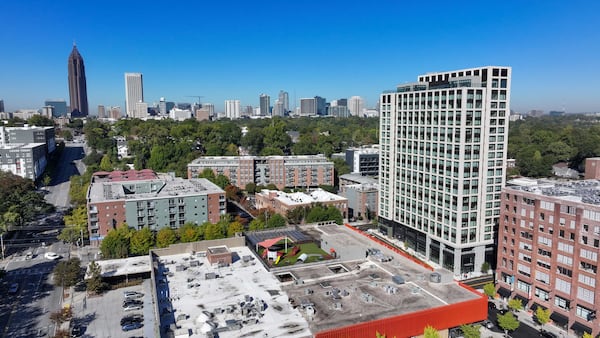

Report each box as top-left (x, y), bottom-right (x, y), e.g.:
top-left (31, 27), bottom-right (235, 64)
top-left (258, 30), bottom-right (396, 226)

top-left (379, 67), bottom-right (511, 277)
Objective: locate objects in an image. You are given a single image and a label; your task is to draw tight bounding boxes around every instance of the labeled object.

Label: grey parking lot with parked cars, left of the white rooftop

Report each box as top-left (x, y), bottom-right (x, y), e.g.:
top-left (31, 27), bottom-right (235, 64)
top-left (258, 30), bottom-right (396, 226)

top-left (70, 279), bottom-right (155, 338)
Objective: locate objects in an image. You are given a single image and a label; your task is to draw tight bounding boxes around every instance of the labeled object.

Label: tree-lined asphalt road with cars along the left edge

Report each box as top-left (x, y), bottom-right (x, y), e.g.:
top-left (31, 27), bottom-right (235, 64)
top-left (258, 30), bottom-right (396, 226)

top-left (0, 143), bottom-right (85, 338)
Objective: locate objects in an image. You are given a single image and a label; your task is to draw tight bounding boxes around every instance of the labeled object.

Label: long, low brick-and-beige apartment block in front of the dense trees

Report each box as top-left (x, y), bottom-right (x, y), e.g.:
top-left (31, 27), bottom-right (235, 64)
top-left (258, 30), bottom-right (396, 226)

top-left (188, 155), bottom-right (334, 189)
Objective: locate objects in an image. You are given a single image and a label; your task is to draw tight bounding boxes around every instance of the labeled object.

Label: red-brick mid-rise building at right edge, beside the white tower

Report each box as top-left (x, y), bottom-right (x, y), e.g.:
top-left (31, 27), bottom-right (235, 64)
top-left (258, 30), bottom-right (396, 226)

top-left (496, 178), bottom-right (600, 336)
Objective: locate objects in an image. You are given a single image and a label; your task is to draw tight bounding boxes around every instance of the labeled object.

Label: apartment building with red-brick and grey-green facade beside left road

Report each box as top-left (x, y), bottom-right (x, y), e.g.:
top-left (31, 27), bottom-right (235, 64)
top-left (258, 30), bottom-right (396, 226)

top-left (87, 169), bottom-right (226, 243)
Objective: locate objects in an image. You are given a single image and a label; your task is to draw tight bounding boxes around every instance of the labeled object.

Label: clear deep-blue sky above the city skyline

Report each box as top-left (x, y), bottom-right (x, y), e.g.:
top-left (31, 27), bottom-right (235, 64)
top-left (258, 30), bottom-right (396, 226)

top-left (0, 0), bottom-right (600, 114)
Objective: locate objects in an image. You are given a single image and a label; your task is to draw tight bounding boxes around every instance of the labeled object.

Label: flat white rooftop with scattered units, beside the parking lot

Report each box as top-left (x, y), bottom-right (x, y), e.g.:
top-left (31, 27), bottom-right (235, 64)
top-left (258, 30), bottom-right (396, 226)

top-left (157, 247), bottom-right (312, 338)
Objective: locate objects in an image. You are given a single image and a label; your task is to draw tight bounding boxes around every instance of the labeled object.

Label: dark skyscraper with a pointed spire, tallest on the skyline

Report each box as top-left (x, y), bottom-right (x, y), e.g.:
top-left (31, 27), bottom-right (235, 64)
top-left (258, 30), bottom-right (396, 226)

top-left (68, 44), bottom-right (88, 117)
